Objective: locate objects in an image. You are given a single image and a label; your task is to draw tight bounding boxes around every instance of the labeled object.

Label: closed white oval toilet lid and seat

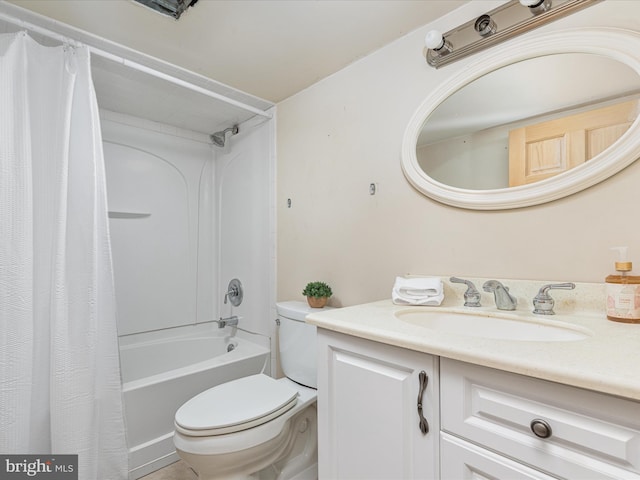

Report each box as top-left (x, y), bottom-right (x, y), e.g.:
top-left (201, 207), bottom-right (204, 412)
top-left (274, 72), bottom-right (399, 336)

top-left (175, 374), bottom-right (298, 436)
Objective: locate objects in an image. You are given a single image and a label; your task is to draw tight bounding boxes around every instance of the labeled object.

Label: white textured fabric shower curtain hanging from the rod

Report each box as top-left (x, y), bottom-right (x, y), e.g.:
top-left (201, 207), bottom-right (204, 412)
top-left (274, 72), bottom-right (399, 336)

top-left (0, 32), bottom-right (128, 480)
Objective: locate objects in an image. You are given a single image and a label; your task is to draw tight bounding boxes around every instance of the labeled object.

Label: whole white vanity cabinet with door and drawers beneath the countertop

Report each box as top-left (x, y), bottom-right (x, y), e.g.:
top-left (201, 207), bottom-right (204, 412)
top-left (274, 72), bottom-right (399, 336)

top-left (318, 328), bottom-right (640, 480)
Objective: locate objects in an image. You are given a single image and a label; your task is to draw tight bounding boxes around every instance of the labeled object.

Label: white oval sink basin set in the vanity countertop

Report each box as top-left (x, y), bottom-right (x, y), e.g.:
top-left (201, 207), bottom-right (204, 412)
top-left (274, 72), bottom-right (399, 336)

top-left (395, 309), bottom-right (591, 342)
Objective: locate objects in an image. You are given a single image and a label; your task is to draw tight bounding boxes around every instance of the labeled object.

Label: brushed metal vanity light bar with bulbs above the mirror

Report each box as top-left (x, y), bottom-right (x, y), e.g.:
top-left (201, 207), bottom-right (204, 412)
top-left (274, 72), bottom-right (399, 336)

top-left (425, 0), bottom-right (602, 68)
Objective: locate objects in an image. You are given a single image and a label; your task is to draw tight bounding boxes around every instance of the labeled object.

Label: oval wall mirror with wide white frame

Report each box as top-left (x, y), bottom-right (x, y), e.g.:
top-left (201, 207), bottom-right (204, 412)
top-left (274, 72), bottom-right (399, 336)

top-left (402, 29), bottom-right (640, 210)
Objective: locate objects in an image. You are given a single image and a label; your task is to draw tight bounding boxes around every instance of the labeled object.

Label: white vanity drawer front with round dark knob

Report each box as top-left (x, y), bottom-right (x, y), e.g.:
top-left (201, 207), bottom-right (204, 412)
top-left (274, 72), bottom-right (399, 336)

top-left (440, 358), bottom-right (640, 480)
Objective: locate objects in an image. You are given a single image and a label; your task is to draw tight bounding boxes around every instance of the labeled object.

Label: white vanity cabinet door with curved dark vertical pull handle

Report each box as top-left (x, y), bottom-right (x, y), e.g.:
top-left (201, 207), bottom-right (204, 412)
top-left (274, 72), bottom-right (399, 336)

top-left (318, 329), bottom-right (440, 480)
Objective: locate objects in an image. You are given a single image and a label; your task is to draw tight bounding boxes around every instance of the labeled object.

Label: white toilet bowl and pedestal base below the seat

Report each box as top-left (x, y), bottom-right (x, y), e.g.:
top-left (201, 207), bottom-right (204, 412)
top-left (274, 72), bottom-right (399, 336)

top-left (178, 402), bottom-right (318, 480)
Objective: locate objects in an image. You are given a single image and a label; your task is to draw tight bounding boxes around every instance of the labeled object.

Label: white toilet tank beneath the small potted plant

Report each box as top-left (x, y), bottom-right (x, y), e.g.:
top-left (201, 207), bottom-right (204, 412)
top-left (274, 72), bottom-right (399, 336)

top-left (276, 301), bottom-right (332, 388)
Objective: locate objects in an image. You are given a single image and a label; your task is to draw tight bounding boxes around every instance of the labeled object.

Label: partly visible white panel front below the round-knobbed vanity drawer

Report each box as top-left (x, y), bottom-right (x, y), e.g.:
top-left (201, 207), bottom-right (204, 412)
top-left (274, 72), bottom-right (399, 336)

top-left (440, 432), bottom-right (557, 480)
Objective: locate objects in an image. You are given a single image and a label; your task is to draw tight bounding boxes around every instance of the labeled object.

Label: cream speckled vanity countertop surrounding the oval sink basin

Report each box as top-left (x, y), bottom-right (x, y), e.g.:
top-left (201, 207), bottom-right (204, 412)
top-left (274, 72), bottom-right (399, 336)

top-left (306, 284), bottom-right (640, 400)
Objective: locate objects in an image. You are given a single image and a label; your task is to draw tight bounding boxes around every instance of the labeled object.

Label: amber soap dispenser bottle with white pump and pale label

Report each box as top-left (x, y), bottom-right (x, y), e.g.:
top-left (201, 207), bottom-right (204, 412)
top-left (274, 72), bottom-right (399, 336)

top-left (605, 247), bottom-right (640, 323)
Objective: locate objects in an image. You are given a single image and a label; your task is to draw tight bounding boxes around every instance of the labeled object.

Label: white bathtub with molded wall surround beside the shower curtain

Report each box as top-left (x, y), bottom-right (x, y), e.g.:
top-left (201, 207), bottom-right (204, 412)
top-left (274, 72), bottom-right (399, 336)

top-left (101, 110), bottom-right (274, 478)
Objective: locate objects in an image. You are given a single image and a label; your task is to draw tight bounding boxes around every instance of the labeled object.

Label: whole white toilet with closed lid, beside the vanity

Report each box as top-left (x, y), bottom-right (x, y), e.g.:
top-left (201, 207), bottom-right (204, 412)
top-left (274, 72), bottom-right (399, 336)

top-left (173, 302), bottom-right (329, 480)
